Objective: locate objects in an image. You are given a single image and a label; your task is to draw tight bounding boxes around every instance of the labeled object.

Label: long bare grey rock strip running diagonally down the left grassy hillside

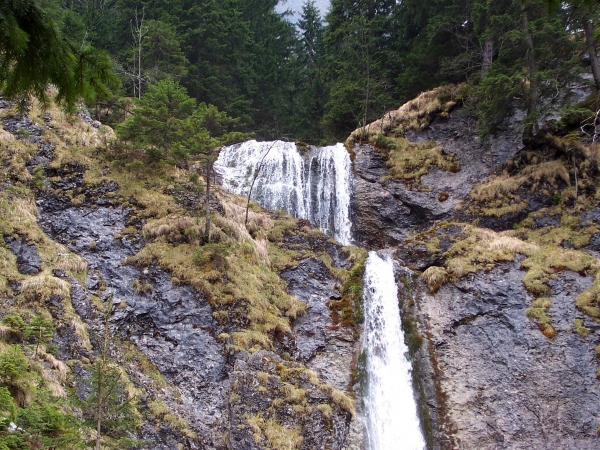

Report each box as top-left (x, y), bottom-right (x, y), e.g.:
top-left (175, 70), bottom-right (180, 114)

top-left (38, 201), bottom-right (227, 448)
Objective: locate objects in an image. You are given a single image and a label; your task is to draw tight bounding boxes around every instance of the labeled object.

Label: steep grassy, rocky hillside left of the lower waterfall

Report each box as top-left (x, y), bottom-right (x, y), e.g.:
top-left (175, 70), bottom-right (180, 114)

top-left (0, 101), bottom-right (365, 449)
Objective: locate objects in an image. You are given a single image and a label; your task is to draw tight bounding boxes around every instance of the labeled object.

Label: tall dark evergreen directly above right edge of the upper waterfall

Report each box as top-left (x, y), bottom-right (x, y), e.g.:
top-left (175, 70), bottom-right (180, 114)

top-left (323, 0), bottom-right (395, 138)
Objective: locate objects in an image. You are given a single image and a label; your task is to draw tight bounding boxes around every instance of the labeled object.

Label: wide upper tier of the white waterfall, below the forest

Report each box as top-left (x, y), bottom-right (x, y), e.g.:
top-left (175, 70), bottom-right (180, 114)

top-left (215, 141), bottom-right (352, 245)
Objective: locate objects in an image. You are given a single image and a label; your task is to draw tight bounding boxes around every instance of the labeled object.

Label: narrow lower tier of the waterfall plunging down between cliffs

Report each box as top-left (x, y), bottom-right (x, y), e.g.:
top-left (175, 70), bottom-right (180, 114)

top-left (364, 252), bottom-right (425, 450)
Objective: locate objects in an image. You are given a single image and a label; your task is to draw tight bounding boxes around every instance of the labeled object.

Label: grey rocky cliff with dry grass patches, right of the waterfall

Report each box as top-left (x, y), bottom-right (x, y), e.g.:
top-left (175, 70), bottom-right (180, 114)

top-left (352, 82), bottom-right (600, 449)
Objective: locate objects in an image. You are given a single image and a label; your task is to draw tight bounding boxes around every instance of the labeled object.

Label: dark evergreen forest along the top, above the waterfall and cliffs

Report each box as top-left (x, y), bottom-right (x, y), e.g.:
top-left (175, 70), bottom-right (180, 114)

top-left (16, 0), bottom-right (600, 143)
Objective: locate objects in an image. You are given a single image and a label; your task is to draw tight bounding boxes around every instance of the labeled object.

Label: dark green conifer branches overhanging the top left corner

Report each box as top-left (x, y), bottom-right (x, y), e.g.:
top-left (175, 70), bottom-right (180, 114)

top-left (0, 0), bottom-right (114, 110)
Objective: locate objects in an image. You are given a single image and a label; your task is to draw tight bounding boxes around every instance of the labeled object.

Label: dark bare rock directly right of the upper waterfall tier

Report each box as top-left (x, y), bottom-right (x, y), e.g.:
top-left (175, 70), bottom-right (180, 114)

top-left (352, 109), bottom-right (522, 249)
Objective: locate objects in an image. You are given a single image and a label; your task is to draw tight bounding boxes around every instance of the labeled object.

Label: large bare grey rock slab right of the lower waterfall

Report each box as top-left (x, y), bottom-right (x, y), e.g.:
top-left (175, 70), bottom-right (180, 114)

top-left (417, 260), bottom-right (600, 449)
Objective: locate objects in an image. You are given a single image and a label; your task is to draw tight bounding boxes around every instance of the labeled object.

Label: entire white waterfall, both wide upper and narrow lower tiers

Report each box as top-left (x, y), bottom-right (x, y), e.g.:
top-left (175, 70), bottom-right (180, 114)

top-left (215, 141), bottom-right (425, 450)
